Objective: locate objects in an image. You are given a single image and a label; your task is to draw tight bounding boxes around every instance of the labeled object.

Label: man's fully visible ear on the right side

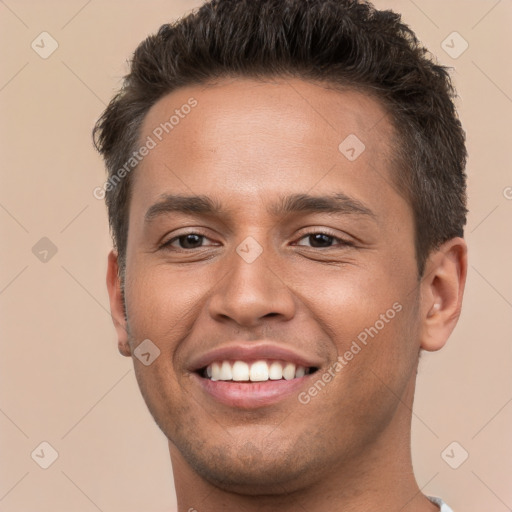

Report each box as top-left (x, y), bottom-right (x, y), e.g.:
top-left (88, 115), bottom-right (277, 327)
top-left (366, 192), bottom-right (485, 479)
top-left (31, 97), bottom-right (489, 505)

top-left (420, 237), bottom-right (467, 351)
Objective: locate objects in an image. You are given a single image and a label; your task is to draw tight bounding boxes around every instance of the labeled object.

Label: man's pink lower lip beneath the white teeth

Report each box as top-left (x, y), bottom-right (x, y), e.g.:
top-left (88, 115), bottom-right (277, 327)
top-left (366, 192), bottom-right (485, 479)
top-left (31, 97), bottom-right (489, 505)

top-left (194, 374), bottom-right (312, 409)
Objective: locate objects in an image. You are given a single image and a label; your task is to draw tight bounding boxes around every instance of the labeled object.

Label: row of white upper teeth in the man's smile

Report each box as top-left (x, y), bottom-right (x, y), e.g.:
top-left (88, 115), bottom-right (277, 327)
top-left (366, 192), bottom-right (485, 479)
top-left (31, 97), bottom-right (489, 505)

top-left (206, 360), bottom-right (309, 382)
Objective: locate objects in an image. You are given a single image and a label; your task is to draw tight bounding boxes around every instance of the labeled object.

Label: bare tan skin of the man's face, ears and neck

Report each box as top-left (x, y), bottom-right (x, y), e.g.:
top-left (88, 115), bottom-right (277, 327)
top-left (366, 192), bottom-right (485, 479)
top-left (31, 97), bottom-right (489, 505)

top-left (107, 79), bottom-right (467, 512)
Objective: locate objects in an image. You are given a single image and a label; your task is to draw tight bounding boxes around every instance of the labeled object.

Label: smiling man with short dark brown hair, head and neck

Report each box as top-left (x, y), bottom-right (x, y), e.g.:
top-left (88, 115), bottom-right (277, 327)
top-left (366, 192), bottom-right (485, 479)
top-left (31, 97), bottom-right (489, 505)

top-left (95, 0), bottom-right (467, 512)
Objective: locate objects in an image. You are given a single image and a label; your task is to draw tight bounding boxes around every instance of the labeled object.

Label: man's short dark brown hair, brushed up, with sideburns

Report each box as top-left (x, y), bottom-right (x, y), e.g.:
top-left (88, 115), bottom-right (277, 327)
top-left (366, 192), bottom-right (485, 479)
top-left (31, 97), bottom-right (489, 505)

top-left (93, 0), bottom-right (467, 277)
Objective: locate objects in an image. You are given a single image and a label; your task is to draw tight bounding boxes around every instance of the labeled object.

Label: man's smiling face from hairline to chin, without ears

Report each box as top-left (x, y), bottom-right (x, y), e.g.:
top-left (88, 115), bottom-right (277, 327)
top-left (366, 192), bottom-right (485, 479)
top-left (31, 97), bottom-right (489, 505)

top-left (114, 79), bottom-right (426, 492)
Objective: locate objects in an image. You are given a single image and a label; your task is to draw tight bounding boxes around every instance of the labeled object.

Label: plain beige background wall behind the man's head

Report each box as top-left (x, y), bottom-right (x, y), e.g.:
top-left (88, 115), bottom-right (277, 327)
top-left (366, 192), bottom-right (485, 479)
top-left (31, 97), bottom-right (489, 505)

top-left (0, 0), bottom-right (512, 512)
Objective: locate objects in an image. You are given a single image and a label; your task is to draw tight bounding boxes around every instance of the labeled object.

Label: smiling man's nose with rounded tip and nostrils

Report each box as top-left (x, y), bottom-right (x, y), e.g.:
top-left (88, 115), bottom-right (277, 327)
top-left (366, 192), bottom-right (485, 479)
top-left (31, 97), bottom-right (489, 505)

top-left (209, 243), bottom-right (296, 327)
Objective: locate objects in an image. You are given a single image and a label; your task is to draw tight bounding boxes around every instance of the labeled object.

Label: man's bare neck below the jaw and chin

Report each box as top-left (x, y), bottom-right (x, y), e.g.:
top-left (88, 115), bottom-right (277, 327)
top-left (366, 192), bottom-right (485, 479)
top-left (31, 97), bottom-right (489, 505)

top-left (169, 376), bottom-right (439, 512)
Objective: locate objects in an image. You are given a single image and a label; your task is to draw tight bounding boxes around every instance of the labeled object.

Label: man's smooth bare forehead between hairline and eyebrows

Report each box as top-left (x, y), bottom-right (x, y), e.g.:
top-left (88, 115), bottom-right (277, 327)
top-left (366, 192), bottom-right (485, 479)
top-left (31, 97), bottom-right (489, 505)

top-left (133, 78), bottom-right (404, 220)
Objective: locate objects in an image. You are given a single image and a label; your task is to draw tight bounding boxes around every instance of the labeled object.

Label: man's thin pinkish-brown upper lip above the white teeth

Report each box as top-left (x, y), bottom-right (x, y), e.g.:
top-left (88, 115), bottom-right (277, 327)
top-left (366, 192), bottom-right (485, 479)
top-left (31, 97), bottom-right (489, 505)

top-left (190, 340), bottom-right (322, 371)
